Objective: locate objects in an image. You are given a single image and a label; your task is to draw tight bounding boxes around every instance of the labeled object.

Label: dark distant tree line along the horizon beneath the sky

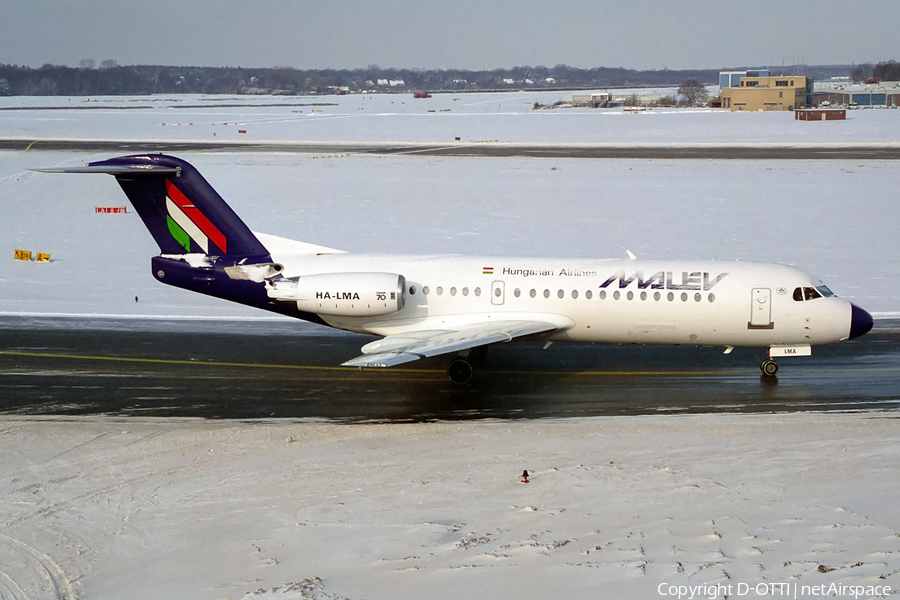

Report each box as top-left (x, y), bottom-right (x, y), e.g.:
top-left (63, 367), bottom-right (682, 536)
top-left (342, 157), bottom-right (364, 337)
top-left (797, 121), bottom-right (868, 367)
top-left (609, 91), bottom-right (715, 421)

top-left (0, 59), bottom-right (864, 96)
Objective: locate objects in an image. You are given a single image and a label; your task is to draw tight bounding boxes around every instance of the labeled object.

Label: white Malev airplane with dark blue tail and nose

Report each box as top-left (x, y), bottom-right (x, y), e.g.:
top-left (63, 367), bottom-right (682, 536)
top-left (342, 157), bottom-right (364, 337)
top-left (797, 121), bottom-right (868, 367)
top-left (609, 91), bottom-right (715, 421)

top-left (36, 154), bottom-right (873, 384)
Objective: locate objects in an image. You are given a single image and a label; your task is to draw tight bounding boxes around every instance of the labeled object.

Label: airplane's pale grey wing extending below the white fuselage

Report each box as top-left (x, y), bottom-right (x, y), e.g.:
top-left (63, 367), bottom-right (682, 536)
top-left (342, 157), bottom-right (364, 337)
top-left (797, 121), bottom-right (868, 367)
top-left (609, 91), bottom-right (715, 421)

top-left (343, 320), bottom-right (564, 367)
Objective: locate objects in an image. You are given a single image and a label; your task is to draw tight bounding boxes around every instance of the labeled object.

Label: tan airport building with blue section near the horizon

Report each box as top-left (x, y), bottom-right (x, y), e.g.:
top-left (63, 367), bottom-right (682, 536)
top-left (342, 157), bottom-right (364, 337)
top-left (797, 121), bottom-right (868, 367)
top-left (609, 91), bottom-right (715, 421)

top-left (719, 70), bottom-right (813, 111)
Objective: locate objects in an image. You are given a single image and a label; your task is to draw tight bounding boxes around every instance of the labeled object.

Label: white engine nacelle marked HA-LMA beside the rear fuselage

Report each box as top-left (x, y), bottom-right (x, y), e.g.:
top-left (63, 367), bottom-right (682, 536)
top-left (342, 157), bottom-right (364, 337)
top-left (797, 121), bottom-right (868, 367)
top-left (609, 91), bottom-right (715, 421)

top-left (293, 273), bottom-right (406, 317)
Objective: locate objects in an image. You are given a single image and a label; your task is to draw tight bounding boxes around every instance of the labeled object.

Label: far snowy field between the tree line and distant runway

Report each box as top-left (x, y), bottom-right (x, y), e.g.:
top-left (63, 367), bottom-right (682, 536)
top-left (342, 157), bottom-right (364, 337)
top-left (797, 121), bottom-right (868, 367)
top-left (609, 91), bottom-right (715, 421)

top-left (0, 90), bottom-right (900, 145)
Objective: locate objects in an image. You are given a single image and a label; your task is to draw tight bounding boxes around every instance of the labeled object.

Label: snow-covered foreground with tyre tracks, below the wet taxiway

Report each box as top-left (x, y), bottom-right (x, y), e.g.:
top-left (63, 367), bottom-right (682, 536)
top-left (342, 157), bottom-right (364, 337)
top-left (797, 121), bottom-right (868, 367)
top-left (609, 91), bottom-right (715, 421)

top-left (0, 414), bottom-right (900, 600)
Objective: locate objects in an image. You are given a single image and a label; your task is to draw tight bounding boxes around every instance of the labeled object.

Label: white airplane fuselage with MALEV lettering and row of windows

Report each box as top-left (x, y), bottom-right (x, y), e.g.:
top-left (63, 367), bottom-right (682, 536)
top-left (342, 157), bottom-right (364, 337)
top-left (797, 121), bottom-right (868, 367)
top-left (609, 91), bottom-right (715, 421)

top-left (273, 252), bottom-right (851, 347)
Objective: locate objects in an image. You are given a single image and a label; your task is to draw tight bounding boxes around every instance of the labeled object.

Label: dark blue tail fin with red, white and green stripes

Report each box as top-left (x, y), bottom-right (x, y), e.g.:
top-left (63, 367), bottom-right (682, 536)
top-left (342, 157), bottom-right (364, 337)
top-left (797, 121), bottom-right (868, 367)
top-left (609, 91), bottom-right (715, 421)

top-left (43, 154), bottom-right (269, 257)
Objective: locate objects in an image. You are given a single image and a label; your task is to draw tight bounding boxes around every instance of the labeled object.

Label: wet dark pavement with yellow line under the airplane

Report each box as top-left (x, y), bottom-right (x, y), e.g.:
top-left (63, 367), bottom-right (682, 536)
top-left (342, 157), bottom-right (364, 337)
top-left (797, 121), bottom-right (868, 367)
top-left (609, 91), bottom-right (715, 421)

top-left (0, 317), bottom-right (900, 422)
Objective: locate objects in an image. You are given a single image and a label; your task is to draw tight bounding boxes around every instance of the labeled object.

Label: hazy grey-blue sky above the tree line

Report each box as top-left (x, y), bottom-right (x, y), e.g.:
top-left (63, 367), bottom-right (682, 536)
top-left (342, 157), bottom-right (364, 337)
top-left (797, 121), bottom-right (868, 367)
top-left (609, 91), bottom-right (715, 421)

top-left (0, 0), bottom-right (900, 70)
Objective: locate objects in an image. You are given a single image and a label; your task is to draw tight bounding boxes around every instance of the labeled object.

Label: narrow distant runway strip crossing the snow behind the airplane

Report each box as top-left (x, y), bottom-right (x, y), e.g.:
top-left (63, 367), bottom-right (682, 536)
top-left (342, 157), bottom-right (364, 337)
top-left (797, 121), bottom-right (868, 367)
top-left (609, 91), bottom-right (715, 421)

top-left (0, 138), bottom-right (900, 160)
